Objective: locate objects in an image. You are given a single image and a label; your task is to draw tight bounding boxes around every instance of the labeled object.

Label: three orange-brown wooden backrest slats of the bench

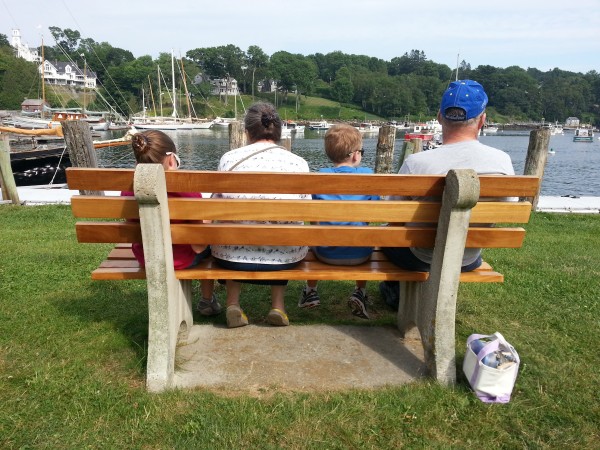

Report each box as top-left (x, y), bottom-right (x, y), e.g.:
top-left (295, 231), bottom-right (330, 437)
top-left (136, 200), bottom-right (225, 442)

top-left (67, 168), bottom-right (539, 255)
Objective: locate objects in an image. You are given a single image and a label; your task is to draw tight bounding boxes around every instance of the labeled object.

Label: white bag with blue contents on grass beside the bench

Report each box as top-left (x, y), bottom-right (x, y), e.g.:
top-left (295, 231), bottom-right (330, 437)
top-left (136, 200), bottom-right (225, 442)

top-left (463, 332), bottom-right (520, 403)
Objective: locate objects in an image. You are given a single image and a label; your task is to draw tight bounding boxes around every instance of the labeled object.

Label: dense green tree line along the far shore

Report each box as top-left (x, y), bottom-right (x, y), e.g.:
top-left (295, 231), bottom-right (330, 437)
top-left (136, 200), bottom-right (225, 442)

top-left (0, 27), bottom-right (600, 124)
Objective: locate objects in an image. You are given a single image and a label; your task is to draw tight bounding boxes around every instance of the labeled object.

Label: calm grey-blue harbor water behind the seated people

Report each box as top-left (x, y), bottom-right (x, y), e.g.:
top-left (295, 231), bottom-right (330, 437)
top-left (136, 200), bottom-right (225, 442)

top-left (98, 130), bottom-right (600, 196)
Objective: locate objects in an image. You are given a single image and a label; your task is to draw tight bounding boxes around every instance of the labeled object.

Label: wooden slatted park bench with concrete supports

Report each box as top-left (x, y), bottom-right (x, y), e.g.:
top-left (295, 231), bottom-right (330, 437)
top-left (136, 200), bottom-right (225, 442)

top-left (67, 164), bottom-right (539, 391)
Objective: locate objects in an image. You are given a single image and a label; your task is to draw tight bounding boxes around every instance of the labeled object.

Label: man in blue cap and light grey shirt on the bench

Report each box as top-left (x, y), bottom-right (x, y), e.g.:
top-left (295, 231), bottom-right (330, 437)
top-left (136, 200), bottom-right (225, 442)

top-left (379, 80), bottom-right (515, 308)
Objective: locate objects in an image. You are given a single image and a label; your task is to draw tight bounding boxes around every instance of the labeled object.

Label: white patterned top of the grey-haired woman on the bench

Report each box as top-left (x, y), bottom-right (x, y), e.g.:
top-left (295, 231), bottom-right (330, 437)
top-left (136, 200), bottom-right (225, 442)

top-left (211, 142), bottom-right (311, 264)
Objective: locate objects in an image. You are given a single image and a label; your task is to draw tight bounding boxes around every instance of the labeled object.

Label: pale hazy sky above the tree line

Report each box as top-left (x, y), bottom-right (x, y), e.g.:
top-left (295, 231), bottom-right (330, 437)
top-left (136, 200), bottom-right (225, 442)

top-left (0, 0), bottom-right (600, 73)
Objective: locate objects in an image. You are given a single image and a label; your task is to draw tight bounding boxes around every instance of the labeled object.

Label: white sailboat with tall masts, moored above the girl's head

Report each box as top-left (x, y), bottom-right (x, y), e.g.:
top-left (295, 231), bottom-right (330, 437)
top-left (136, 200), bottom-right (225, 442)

top-left (132, 51), bottom-right (213, 130)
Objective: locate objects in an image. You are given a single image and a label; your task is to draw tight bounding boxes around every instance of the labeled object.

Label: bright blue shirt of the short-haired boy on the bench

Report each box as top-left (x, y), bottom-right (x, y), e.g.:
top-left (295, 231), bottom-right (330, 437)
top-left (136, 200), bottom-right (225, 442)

top-left (312, 166), bottom-right (380, 259)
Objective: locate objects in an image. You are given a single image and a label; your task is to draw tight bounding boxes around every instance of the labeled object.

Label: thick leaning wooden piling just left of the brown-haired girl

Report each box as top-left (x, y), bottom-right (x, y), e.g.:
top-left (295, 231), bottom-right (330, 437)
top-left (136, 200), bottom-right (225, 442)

top-left (61, 120), bottom-right (104, 195)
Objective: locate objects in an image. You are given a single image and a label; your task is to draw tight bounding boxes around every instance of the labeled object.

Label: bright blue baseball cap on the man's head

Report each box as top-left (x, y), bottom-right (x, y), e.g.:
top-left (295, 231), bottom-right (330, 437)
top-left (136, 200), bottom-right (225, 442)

top-left (440, 80), bottom-right (487, 121)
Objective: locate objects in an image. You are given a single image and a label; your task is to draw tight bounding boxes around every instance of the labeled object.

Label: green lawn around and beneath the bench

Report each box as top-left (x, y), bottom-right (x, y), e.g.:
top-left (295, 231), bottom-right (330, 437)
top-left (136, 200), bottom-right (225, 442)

top-left (0, 205), bottom-right (600, 449)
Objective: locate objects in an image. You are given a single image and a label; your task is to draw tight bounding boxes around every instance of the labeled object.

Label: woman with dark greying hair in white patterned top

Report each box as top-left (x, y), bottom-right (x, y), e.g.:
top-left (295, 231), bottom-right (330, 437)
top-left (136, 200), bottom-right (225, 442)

top-left (212, 102), bottom-right (310, 328)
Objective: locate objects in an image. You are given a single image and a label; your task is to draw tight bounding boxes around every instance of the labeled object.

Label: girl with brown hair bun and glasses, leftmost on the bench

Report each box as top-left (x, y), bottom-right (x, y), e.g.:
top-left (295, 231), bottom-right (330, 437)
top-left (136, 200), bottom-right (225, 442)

top-left (121, 130), bottom-right (222, 316)
